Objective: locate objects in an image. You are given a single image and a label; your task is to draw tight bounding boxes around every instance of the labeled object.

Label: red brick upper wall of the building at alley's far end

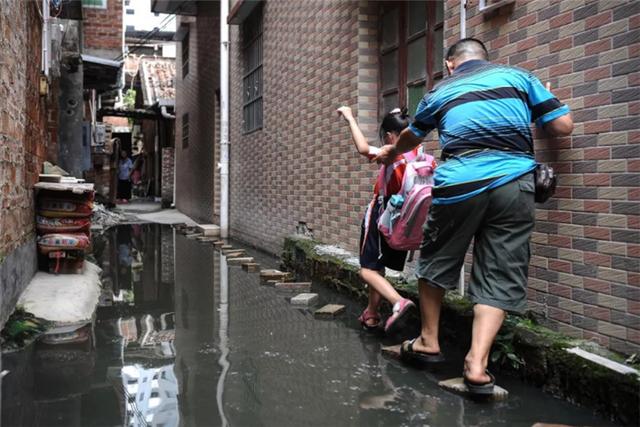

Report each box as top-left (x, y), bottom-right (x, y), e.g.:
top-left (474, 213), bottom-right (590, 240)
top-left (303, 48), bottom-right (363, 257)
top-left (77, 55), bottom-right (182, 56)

top-left (82, 0), bottom-right (124, 59)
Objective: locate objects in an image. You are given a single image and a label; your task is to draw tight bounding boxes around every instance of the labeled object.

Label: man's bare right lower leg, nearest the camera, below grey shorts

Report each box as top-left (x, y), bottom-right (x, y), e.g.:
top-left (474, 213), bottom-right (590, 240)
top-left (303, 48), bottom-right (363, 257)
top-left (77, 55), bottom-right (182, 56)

top-left (464, 304), bottom-right (505, 383)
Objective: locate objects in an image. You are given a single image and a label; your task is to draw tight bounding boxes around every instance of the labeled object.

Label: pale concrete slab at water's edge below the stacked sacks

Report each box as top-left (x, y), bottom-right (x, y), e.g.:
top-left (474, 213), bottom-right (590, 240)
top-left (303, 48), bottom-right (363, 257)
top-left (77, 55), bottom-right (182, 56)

top-left (18, 261), bottom-right (102, 332)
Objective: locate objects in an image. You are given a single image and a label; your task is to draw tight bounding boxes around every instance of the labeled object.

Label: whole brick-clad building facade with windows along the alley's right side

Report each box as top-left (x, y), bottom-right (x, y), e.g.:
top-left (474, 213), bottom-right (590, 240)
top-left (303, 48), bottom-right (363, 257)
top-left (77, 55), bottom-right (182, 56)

top-left (169, 0), bottom-right (640, 354)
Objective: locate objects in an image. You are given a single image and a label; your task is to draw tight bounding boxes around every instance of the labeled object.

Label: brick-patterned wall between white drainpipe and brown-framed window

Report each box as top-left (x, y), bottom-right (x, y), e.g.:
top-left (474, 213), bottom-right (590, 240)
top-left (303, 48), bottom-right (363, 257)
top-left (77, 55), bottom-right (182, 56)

top-left (230, 1), bottom-right (377, 253)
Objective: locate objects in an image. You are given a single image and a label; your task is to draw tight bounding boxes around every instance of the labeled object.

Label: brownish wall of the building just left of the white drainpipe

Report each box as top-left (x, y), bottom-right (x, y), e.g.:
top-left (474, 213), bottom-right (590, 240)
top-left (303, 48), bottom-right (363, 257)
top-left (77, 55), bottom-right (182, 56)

top-left (175, 2), bottom-right (220, 223)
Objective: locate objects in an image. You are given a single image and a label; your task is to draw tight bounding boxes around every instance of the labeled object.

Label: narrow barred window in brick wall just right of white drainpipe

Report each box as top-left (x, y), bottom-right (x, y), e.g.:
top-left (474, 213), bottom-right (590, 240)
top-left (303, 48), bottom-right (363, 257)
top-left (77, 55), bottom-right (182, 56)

top-left (242, 6), bottom-right (262, 133)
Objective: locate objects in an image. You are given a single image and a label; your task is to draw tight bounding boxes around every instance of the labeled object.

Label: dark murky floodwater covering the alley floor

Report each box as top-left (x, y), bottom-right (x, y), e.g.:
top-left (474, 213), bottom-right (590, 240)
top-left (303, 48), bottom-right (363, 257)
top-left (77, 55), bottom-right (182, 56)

top-left (2, 224), bottom-right (610, 427)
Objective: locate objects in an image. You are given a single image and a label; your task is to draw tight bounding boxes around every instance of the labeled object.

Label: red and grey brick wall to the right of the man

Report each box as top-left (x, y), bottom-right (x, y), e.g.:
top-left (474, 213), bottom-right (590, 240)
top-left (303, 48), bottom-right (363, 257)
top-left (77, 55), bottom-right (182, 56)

top-left (446, 0), bottom-right (640, 353)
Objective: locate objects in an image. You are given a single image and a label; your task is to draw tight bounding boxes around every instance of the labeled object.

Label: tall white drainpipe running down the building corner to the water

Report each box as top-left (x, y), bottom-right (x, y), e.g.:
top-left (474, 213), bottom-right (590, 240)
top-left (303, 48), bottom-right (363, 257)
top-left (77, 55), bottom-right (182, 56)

top-left (218, 0), bottom-right (229, 239)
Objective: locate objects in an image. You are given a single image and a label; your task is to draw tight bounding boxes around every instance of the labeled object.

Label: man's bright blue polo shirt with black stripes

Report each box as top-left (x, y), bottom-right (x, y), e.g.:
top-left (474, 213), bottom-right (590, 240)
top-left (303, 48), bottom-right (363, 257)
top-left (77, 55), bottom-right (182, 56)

top-left (409, 60), bottom-right (569, 204)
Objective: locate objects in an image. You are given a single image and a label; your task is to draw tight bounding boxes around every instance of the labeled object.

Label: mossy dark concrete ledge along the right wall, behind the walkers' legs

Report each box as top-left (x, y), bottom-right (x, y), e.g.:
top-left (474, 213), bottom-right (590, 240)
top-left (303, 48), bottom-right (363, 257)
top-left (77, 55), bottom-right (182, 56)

top-left (282, 236), bottom-right (640, 425)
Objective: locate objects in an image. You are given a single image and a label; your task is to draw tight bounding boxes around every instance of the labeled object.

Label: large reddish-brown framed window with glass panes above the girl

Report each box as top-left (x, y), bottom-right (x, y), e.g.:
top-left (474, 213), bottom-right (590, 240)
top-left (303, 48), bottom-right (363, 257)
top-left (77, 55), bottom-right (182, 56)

top-left (380, 1), bottom-right (444, 116)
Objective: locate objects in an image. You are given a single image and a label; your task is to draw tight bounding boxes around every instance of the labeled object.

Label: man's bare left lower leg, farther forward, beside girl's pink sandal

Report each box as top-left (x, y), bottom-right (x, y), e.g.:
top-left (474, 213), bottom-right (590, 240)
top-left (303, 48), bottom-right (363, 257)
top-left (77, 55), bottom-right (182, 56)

top-left (413, 279), bottom-right (444, 353)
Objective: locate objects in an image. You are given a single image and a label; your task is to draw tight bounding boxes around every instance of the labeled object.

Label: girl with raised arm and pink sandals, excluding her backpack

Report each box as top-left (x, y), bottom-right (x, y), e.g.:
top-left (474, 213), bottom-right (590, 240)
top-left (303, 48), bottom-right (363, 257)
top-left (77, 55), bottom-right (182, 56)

top-left (337, 106), bottom-right (418, 334)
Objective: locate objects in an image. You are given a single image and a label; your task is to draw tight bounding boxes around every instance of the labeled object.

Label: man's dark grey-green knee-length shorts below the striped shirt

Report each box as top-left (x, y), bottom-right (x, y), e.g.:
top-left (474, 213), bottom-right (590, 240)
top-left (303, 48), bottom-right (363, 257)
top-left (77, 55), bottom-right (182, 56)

top-left (416, 173), bottom-right (535, 312)
